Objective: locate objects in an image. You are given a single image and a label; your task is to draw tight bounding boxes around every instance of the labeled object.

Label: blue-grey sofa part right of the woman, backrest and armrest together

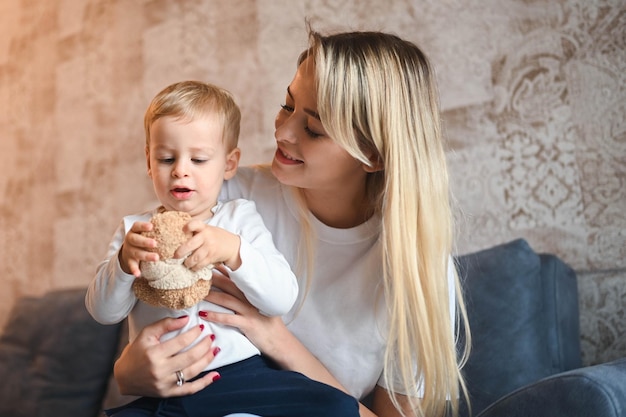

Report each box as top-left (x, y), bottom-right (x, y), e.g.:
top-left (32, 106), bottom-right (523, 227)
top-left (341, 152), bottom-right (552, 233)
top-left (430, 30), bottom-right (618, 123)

top-left (457, 239), bottom-right (626, 417)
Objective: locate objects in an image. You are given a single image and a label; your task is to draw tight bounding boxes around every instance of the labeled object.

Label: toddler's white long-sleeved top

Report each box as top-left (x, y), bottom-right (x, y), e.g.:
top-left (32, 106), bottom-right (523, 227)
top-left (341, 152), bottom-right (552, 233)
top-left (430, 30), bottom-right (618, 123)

top-left (85, 199), bottom-right (298, 370)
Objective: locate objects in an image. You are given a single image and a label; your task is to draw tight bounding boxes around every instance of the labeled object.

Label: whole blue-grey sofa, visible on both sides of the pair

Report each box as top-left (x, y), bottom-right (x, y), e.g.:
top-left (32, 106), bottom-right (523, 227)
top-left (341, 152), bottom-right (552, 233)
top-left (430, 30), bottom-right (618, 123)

top-left (0, 239), bottom-right (626, 417)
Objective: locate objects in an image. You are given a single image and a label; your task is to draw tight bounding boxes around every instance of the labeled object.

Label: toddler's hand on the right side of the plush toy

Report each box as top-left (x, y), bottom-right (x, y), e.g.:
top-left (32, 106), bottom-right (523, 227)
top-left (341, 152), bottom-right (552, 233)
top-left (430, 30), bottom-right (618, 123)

top-left (174, 220), bottom-right (241, 271)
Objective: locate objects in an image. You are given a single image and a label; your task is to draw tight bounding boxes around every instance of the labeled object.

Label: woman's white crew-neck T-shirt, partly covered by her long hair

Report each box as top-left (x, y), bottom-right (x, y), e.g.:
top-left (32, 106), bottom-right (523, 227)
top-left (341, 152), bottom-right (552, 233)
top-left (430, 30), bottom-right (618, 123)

top-left (221, 168), bottom-right (455, 399)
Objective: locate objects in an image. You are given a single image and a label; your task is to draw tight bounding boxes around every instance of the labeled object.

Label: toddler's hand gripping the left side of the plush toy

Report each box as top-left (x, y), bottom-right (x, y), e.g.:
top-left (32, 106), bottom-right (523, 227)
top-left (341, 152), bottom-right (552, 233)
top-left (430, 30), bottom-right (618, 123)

top-left (118, 222), bottom-right (159, 277)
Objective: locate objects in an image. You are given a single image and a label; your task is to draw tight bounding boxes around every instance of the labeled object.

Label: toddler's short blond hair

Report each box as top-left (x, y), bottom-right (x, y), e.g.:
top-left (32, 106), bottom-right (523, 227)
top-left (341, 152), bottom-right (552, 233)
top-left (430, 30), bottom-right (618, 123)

top-left (144, 81), bottom-right (241, 150)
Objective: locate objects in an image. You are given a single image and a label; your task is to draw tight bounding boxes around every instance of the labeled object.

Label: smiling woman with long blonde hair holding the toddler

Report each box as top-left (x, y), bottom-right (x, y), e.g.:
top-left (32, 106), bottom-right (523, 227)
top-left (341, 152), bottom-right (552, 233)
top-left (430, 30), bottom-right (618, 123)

top-left (115, 27), bottom-right (469, 417)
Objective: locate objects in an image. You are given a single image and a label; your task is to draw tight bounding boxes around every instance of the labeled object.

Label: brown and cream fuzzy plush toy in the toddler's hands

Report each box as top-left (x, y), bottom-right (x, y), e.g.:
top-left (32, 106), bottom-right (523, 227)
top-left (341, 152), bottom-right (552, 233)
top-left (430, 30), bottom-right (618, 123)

top-left (133, 211), bottom-right (213, 310)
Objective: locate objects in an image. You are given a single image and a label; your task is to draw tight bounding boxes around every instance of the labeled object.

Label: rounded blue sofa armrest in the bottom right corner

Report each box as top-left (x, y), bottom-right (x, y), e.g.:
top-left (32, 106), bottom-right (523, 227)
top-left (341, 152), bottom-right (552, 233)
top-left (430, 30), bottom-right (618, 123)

top-left (478, 358), bottom-right (626, 417)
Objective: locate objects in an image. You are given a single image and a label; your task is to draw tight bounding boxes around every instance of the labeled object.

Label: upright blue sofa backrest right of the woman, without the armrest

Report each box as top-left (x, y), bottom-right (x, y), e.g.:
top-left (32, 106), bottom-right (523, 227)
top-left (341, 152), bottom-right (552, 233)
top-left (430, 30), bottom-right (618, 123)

top-left (457, 239), bottom-right (580, 416)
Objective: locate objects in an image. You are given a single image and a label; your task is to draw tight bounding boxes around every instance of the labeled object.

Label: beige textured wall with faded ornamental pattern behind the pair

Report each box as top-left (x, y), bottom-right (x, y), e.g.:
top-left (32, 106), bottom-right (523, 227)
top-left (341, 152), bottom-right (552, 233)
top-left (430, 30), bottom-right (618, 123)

top-left (0, 0), bottom-right (626, 363)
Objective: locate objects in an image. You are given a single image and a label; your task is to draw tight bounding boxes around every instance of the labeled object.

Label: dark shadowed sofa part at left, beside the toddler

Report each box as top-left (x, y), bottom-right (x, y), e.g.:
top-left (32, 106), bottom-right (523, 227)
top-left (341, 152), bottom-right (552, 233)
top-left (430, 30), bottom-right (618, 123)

top-left (0, 288), bottom-right (120, 417)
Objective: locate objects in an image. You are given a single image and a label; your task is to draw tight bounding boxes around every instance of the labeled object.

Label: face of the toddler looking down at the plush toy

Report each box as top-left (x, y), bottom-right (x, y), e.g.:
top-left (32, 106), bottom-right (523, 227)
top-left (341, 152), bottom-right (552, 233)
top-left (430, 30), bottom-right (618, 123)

top-left (146, 115), bottom-right (236, 220)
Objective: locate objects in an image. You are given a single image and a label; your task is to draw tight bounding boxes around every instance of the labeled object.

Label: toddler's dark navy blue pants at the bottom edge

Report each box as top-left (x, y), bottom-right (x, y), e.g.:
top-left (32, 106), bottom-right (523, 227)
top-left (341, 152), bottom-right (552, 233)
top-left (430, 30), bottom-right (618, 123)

top-left (107, 356), bottom-right (359, 417)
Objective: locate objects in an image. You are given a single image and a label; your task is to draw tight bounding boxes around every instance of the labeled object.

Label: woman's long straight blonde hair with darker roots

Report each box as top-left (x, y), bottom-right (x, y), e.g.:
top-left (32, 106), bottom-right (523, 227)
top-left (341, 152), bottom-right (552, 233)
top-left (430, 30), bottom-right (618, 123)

top-left (299, 29), bottom-right (470, 416)
